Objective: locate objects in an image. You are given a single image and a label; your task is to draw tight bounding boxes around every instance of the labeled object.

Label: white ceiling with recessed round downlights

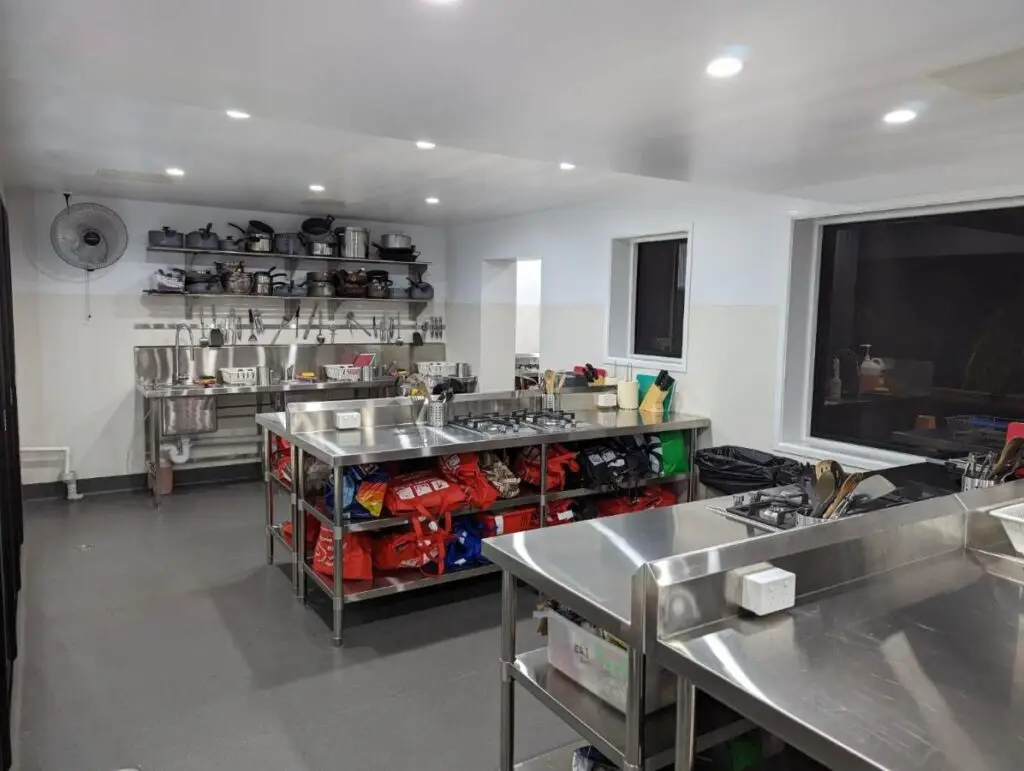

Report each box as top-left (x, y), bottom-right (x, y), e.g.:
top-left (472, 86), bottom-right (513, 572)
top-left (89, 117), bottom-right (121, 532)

top-left (0, 0), bottom-right (1024, 223)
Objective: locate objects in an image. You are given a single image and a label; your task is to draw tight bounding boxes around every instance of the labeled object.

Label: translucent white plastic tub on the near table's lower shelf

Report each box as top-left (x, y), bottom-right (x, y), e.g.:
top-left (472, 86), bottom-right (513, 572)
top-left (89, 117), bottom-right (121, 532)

top-left (548, 613), bottom-right (676, 713)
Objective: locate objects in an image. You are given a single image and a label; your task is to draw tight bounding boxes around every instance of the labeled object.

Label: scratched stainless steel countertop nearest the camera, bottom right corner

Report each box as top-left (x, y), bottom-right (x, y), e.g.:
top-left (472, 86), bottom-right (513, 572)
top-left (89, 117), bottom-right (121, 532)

top-left (655, 548), bottom-right (1024, 771)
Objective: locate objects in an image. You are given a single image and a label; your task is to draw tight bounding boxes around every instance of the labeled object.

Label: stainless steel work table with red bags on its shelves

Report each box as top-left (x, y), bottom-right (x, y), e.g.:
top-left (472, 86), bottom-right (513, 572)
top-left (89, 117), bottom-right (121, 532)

top-left (256, 392), bottom-right (710, 645)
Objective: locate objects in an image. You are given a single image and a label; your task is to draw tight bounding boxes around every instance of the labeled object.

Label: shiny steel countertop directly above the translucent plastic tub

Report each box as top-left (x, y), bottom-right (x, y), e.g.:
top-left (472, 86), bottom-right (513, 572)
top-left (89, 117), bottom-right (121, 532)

top-left (483, 497), bottom-right (772, 642)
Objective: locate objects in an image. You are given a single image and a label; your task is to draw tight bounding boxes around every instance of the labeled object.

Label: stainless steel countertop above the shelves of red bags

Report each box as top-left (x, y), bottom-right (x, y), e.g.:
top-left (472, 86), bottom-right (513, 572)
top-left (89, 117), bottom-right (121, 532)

top-left (256, 410), bottom-right (711, 466)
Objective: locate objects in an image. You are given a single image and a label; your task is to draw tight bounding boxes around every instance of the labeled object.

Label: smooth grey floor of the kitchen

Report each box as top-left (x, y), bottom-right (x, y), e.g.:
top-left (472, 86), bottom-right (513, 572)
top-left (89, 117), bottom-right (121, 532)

top-left (18, 483), bottom-right (575, 771)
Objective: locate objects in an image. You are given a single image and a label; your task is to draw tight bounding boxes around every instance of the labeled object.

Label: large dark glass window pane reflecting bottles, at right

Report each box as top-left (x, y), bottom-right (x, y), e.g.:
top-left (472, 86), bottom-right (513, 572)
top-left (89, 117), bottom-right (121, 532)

top-left (811, 208), bottom-right (1024, 458)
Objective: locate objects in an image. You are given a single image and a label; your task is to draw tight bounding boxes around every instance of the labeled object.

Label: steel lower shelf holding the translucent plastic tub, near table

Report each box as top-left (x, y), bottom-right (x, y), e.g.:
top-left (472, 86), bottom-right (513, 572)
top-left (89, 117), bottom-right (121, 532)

top-left (510, 648), bottom-right (754, 769)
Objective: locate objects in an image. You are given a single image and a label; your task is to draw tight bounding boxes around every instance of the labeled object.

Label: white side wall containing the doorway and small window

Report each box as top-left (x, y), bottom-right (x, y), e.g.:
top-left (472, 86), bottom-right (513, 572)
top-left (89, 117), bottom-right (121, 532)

top-left (447, 182), bottom-right (803, 448)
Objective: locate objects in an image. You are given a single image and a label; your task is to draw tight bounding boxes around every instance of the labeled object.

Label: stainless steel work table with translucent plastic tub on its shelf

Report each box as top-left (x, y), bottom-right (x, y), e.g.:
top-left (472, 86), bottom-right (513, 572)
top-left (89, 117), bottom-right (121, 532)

top-left (483, 499), bottom-right (771, 771)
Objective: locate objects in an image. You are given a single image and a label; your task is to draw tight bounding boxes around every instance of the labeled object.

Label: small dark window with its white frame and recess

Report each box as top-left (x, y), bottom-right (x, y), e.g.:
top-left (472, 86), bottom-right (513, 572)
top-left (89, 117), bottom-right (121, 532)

top-left (608, 232), bottom-right (690, 371)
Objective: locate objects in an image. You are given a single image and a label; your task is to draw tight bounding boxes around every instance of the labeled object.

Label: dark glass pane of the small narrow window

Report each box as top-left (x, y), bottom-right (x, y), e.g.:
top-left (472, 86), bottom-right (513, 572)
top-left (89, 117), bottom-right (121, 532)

top-left (633, 239), bottom-right (686, 358)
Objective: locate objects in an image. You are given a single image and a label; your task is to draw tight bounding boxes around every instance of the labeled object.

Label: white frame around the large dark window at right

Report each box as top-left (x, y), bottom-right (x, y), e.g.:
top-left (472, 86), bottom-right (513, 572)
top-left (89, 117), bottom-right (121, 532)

top-left (775, 196), bottom-right (1024, 470)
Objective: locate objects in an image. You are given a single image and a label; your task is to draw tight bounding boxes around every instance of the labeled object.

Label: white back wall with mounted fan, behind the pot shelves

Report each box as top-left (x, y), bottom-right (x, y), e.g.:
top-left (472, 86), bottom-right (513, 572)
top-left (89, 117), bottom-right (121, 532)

top-left (7, 188), bottom-right (446, 483)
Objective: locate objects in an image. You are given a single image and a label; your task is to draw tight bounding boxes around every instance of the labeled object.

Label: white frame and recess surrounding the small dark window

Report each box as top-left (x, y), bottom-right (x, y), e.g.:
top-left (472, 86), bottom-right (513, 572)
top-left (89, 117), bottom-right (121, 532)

top-left (604, 227), bottom-right (693, 373)
